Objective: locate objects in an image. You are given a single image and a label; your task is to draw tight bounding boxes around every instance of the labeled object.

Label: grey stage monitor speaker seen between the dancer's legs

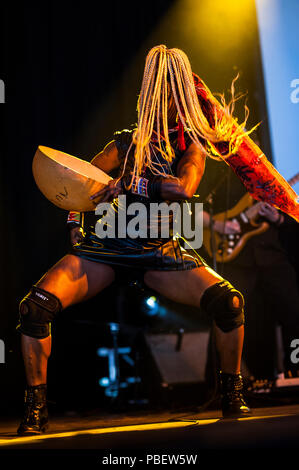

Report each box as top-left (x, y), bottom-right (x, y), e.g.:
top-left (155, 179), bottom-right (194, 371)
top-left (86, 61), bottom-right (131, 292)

top-left (145, 331), bottom-right (210, 385)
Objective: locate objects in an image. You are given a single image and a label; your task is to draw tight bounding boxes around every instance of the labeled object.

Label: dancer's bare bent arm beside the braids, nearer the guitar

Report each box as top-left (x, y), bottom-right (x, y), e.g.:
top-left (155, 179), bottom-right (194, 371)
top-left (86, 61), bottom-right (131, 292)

top-left (160, 143), bottom-right (205, 201)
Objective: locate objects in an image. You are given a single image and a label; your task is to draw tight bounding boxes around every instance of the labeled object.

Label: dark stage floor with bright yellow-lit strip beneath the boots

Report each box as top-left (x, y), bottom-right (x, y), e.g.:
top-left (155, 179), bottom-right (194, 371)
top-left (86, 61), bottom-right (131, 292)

top-left (0, 405), bottom-right (299, 456)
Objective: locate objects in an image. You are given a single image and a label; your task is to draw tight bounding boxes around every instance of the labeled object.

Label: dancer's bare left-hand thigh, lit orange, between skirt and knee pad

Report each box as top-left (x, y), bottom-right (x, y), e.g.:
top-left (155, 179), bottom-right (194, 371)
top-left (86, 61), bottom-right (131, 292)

top-left (36, 255), bottom-right (115, 308)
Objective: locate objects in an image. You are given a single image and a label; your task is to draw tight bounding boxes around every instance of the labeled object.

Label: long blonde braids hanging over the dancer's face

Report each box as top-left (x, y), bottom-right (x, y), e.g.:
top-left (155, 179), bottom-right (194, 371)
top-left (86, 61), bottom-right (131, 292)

top-left (126, 45), bottom-right (253, 182)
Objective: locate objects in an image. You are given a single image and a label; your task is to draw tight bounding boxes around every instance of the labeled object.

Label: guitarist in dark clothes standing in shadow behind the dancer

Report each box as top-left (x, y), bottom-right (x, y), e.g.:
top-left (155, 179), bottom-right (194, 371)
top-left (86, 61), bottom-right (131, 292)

top-left (198, 159), bottom-right (299, 379)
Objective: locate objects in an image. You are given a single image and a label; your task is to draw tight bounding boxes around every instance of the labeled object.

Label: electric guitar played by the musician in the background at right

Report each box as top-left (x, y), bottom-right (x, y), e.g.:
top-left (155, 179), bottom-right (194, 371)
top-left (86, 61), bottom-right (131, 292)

top-left (203, 173), bottom-right (299, 263)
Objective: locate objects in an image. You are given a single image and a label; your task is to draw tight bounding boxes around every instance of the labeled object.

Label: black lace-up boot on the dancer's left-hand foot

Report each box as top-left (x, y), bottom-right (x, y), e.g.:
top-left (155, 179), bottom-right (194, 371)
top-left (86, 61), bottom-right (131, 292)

top-left (18, 384), bottom-right (48, 436)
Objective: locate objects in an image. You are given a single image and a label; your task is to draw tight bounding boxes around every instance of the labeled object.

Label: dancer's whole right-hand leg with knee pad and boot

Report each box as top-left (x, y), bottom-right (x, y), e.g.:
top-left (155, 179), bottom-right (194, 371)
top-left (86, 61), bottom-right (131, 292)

top-left (144, 267), bottom-right (250, 417)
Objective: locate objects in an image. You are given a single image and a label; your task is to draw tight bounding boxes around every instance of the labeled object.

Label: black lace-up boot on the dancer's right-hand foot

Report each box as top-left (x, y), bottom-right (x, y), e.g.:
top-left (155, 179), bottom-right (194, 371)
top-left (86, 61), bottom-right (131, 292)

top-left (220, 372), bottom-right (251, 418)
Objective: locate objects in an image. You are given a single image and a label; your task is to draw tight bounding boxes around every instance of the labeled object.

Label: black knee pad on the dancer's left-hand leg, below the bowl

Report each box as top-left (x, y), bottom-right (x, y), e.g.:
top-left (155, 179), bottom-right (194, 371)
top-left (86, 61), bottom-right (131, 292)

top-left (17, 286), bottom-right (62, 339)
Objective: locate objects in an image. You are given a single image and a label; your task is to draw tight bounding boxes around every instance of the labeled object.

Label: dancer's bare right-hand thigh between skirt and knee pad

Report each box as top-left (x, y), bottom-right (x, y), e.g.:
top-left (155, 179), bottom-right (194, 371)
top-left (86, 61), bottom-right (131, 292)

top-left (144, 266), bottom-right (223, 307)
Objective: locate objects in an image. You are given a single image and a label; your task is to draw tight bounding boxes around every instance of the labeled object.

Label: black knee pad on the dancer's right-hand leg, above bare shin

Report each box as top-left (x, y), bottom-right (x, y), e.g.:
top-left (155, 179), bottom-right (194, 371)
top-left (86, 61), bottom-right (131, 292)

top-left (200, 281), bottom-right (244, 333)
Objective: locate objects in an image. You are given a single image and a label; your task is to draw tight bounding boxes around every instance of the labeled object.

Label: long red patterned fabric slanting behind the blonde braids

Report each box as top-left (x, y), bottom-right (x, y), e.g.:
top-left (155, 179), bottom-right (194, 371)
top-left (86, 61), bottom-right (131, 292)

top-left (193, 74), bottom-right (299, 222)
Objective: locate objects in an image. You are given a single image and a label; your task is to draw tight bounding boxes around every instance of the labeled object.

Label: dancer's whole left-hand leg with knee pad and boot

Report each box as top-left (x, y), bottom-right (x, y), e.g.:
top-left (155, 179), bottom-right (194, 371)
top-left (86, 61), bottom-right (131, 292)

top-left (18, 255), bottom-right (114, 435)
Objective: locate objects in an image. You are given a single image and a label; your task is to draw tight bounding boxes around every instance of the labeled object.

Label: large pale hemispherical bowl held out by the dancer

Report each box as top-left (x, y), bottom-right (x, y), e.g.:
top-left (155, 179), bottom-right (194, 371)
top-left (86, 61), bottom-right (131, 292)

top-left (32, 145), bottom-right (112, 212)
